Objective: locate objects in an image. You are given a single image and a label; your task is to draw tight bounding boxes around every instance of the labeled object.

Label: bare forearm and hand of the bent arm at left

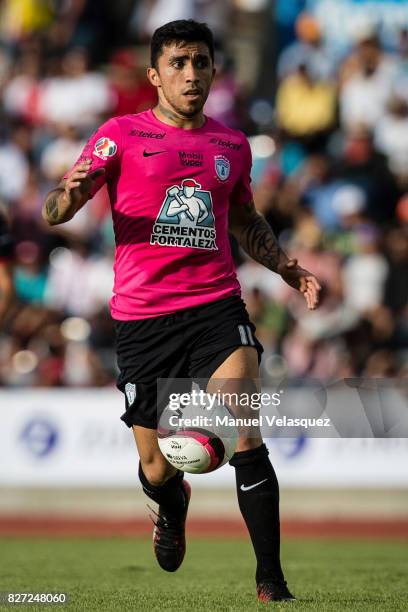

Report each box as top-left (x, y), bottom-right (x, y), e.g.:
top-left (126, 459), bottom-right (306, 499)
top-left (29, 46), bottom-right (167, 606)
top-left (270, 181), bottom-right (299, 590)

top-left (42, 159), bottom-right (105, 225)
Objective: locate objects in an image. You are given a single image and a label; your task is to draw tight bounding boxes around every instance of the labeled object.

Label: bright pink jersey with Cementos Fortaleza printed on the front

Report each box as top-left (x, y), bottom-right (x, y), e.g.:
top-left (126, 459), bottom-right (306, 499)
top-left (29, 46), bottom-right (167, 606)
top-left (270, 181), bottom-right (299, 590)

top-left (65, 110), bottom-right (252, 321)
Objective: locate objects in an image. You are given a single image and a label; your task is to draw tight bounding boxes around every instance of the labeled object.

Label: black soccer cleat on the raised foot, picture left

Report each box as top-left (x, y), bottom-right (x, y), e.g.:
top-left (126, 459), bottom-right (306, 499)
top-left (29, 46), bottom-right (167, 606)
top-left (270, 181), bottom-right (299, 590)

top-left (153, 480), bottom-right (191, 572)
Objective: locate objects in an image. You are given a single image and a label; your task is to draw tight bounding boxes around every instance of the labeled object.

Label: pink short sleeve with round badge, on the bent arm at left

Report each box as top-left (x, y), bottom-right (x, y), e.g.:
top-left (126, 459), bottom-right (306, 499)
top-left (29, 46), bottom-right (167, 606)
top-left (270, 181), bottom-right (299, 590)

top-left (64, 119), bottom-right (122, 196)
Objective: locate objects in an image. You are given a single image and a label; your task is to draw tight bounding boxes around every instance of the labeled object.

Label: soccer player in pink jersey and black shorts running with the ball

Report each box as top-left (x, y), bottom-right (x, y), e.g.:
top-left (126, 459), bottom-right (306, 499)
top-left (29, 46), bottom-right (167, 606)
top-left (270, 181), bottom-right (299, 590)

top-left (43, 20), bottom-right (320, 602)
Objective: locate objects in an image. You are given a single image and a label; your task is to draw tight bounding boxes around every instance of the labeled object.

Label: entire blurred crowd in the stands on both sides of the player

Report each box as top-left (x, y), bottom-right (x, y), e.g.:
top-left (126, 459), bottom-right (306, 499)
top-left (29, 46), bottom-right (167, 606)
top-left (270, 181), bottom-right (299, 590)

top-left (0, 0), bottom-right (408, 386)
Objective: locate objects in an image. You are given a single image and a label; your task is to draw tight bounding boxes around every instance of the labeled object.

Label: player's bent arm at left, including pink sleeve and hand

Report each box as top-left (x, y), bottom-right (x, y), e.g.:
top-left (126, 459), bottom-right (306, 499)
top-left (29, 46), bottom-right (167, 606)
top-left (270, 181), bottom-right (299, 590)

top-left (42, 118), bottom-right (122, 225)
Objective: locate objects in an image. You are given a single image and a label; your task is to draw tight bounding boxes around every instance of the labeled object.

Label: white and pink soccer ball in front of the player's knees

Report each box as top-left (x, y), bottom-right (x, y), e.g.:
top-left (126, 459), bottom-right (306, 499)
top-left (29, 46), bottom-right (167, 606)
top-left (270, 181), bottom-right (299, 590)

top-left (158, 392), bottom-right (238, 474)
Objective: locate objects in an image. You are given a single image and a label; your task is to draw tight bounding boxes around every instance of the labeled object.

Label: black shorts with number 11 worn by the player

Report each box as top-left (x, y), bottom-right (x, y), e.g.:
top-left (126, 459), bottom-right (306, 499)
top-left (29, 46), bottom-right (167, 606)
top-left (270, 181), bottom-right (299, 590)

top-left (115, 296), bottom-right (263, 429)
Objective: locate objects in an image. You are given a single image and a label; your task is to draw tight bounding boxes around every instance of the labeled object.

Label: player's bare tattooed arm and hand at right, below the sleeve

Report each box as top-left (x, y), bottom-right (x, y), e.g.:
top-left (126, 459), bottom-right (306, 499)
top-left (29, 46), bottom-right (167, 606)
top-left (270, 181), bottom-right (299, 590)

top-left (229, 200), bottom-right (321, 310)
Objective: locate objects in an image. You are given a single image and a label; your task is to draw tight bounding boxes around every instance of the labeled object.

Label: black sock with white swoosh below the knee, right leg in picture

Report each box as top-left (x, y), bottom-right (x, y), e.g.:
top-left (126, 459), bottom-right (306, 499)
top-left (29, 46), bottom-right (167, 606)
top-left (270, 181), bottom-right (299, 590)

top-left (230, 444), bottom-right (283, 583)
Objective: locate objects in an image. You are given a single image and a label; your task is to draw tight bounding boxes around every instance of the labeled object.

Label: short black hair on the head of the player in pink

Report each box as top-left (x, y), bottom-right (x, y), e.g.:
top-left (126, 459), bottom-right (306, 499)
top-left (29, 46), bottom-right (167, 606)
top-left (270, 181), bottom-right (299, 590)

top-left (150, 19), bottom-right (214, 68)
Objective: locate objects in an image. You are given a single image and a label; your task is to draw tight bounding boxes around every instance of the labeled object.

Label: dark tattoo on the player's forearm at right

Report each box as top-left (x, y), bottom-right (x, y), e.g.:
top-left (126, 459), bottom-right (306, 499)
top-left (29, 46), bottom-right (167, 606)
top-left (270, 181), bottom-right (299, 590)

top-left (236, 202), bottom-right (288, 272)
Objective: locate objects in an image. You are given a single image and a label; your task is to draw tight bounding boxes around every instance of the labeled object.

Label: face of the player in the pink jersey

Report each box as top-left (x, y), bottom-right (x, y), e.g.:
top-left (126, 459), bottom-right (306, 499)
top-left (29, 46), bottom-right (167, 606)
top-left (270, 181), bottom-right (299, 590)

top-left (149, 42), bottom-right (215, 118)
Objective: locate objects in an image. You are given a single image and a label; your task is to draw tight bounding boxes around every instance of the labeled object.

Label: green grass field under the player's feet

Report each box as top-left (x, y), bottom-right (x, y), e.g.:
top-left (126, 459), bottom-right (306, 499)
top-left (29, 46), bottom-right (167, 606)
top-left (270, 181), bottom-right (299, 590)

top-left (0, 538), bottom-right (408, 612)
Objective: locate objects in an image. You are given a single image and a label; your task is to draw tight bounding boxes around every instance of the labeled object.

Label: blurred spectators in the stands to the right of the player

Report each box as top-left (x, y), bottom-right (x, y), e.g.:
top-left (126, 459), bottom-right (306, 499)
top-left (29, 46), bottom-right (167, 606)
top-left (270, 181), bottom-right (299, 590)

top-left (239, 13), bottom-right (408, 380)
